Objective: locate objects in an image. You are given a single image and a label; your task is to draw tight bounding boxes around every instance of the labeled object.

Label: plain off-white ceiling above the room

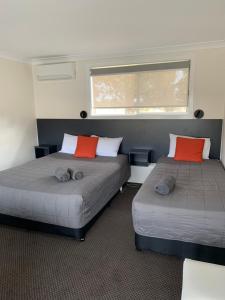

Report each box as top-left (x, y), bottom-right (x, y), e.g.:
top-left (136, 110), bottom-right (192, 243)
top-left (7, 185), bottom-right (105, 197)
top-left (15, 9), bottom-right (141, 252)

top-left (0, 0), bottom-right (225, 59)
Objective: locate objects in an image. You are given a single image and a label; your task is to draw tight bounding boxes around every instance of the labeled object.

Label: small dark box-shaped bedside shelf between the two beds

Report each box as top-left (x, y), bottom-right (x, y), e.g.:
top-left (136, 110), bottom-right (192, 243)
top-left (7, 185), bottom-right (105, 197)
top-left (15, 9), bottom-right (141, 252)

top-left (129, 148), bottom-right (152, 167)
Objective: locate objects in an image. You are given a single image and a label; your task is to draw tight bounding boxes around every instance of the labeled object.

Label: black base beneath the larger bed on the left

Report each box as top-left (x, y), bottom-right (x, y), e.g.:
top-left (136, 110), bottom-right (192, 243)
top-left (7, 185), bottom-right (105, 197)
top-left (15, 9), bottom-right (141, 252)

top-left (0, 192), bottom-right (118, 241)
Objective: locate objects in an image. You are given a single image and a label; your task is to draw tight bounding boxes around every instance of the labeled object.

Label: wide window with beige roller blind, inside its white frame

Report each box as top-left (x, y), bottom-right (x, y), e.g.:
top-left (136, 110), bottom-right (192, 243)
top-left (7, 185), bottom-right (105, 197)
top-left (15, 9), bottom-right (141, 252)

top-left (90, 61), bottom-right (190, 116)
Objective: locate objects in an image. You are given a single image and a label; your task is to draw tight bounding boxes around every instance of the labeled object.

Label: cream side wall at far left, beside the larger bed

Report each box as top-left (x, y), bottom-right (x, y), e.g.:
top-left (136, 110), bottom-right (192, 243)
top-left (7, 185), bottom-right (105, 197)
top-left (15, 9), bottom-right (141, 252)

top-left (0, 59), bottom-right (37, 170)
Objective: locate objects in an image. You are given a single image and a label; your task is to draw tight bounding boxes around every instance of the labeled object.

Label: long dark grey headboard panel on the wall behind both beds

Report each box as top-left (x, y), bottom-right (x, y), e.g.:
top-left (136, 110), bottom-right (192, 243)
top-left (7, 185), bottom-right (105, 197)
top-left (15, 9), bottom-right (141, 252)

top-left (37, 119), bottom-right (222, 161)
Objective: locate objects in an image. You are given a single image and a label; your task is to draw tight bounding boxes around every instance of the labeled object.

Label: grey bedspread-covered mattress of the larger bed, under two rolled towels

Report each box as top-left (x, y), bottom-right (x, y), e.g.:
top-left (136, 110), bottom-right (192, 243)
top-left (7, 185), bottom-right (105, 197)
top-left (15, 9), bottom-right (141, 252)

top-left (0, 153), bottom-right (130, 229)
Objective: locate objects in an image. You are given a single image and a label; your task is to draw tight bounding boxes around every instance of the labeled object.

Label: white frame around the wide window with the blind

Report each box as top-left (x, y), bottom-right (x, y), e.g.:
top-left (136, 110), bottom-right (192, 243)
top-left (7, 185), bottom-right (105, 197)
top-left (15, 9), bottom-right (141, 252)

top-left (86, 55), bottom-right (195, 119)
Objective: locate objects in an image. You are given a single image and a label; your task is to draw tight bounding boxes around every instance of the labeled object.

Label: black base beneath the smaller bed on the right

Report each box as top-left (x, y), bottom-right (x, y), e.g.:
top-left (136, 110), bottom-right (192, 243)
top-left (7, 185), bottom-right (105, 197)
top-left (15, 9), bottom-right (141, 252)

top-left (135, 233), bottom-right (225, 265)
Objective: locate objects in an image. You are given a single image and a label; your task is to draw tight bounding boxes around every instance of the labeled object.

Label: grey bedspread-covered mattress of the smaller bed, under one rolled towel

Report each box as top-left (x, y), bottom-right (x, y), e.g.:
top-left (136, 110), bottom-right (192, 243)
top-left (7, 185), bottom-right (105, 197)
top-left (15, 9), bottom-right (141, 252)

top-left (132, 158), bottom-right (225, 248)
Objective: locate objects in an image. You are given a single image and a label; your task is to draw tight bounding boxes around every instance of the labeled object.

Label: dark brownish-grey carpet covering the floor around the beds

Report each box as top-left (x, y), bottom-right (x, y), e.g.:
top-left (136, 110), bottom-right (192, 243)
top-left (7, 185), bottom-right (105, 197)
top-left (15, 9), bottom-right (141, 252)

top-left (0, 187), bottom-right (182, 300)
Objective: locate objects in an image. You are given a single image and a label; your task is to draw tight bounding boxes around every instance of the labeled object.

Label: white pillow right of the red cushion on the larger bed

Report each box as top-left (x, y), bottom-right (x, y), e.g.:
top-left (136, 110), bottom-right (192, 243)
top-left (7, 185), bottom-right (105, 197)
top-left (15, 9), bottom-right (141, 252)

top-left (92, 137), bottom-right (123, 157)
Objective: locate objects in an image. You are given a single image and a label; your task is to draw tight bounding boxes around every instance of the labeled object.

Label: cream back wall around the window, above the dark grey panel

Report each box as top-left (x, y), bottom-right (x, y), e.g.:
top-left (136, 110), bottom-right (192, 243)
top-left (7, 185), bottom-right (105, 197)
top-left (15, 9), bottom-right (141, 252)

top-left (33, 48), bottom-right (225, 118)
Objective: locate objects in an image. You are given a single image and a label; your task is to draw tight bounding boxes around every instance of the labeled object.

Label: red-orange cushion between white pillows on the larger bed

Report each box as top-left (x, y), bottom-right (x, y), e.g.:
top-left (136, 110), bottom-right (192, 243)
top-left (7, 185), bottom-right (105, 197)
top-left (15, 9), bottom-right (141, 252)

top-left (74, 135), bottom-right (98, 158)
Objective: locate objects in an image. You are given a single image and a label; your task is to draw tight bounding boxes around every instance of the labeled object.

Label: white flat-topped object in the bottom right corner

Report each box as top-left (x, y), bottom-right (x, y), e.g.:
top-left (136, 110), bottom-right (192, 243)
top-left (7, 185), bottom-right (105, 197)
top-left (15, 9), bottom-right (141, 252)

top-left (181, 259), bottom-right (225, 300)
